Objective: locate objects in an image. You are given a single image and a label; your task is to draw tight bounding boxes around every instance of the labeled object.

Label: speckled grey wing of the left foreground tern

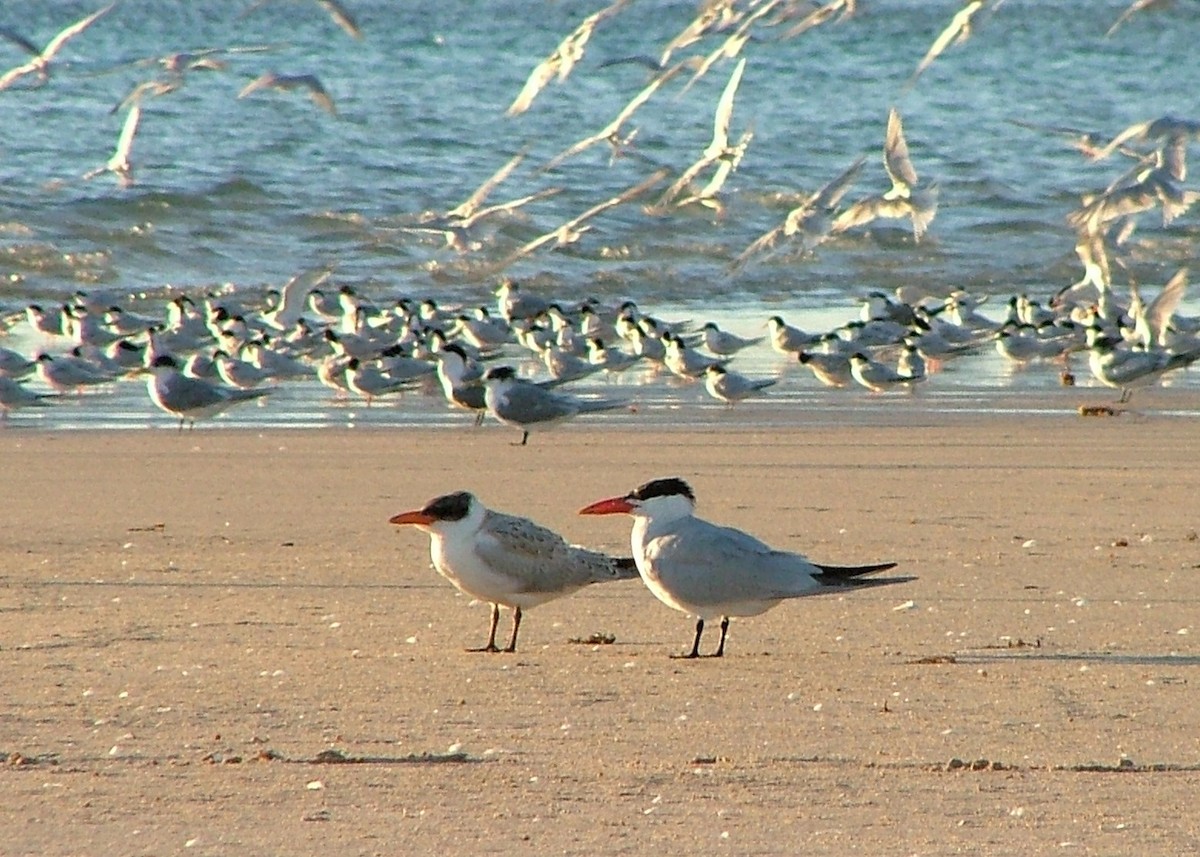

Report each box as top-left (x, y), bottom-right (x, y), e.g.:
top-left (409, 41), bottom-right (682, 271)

top-left (475, 511), bottom-right (636, 593)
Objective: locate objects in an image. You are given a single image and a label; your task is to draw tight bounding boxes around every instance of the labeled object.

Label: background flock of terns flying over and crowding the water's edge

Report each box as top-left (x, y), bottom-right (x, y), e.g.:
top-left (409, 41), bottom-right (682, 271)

top-left (0, 0), bottom-right (1200, 427)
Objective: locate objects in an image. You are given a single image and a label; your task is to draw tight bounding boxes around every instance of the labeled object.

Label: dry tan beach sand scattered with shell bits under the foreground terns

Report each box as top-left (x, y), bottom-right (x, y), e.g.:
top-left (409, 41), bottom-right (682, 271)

top-left (0, 414), bottom-right (1200, 856)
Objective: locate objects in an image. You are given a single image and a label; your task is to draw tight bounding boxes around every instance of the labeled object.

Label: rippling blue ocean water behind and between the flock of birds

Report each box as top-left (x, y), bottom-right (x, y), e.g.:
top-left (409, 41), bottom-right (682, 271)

top-left (0, 0), bottom-right (1200, 426)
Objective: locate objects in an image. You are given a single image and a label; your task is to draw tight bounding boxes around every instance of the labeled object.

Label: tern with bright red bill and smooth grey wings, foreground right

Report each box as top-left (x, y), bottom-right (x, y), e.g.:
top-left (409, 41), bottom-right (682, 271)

top-left (580, 478), bottom-right (913, 658)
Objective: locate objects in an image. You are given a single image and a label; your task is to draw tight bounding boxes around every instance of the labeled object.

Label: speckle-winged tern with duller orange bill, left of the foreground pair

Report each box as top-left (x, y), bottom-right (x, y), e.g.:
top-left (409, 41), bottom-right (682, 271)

top-left (390, 491), bottom-right (637, 652)
